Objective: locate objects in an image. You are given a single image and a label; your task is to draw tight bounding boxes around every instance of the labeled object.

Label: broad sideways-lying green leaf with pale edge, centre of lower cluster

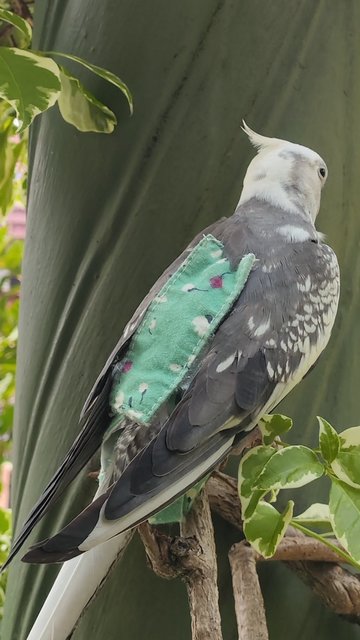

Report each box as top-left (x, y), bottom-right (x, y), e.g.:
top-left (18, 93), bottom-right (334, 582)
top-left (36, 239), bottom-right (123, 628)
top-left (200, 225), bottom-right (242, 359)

top-left (254, 445), bottom-right (324, 491)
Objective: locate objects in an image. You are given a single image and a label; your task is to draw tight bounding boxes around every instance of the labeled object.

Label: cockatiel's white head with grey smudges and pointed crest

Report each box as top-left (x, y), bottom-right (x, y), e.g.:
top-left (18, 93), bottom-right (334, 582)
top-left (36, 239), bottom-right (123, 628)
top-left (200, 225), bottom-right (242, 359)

top-left (239, 122), bottom-right (328, 222)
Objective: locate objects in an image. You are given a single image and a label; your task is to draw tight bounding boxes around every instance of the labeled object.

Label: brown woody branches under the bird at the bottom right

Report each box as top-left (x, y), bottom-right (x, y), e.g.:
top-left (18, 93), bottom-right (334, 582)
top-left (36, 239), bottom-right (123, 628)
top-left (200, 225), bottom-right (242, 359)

top-left (139, 442), bottom-right (360, 640)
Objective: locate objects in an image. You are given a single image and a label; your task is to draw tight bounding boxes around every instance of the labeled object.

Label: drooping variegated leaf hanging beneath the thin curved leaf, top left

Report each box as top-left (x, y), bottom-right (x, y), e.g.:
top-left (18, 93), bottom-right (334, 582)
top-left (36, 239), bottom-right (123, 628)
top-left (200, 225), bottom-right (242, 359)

top-left (58, 67), bottom-right (116, 133)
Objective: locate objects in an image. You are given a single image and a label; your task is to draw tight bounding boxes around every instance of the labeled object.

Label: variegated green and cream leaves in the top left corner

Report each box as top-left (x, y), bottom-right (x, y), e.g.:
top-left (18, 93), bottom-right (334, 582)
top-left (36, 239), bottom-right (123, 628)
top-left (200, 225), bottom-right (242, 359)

top-left (0, 7), bottom-right (133, 133)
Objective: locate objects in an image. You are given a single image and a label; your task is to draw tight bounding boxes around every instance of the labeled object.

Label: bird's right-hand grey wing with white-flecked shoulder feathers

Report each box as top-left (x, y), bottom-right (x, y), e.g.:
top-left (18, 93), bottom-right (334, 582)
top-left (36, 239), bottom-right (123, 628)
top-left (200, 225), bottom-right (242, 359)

top-left (105, 242), bottom-right (340, 520)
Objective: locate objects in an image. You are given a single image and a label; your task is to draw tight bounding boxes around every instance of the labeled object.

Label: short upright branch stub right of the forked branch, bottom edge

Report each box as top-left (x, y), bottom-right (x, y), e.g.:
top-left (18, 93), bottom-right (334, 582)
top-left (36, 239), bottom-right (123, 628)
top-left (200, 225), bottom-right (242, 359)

top-left (229, 542), bottom-right (269, 640)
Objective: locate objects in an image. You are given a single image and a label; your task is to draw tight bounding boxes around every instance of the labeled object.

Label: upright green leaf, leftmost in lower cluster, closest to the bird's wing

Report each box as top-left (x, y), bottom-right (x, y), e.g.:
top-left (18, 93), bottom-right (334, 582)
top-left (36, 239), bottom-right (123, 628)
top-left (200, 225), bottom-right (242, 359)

top-left (238, 445), bottom-right (276, 518)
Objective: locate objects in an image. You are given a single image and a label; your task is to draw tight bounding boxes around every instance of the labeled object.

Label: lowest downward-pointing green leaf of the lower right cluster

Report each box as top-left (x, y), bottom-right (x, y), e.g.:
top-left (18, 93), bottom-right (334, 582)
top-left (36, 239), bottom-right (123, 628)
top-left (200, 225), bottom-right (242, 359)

top-left (244, 500), bottom-right (294, 558)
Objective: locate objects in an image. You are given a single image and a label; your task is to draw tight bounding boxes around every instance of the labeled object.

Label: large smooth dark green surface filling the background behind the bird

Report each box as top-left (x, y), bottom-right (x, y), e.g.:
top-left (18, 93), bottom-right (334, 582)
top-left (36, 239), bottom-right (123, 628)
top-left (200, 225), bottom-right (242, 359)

top-left (2, 0), bottom-right (360, 640)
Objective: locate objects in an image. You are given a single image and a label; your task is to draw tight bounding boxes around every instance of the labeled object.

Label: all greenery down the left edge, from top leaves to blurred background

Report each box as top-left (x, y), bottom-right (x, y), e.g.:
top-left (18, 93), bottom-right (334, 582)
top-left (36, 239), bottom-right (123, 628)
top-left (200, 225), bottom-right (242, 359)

top-left (0, 1), bottom-right (133, 620)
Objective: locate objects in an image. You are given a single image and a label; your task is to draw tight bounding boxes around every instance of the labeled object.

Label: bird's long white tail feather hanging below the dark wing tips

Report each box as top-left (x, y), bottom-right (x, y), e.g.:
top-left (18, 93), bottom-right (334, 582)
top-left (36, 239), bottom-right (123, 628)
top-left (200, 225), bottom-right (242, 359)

top-left (27, 532), bottom-right (132, 640)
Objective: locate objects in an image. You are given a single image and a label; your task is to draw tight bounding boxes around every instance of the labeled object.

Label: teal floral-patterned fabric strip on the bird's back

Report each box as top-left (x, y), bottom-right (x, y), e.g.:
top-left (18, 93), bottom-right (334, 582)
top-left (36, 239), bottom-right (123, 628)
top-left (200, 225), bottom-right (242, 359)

top-left (111, 235), bottom-right (255, 424)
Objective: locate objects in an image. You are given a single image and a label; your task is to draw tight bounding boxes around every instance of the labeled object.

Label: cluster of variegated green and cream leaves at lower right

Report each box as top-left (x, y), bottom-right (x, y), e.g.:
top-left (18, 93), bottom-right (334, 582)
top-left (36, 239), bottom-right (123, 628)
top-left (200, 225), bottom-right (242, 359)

top-left (239, 415), bottom-right (360, 569)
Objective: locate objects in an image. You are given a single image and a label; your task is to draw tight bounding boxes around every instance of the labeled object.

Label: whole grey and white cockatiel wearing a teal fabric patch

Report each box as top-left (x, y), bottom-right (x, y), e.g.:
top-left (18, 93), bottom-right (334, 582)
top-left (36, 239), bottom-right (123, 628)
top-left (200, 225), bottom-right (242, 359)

top-left (3, 123), bottom-right (340, 640)
